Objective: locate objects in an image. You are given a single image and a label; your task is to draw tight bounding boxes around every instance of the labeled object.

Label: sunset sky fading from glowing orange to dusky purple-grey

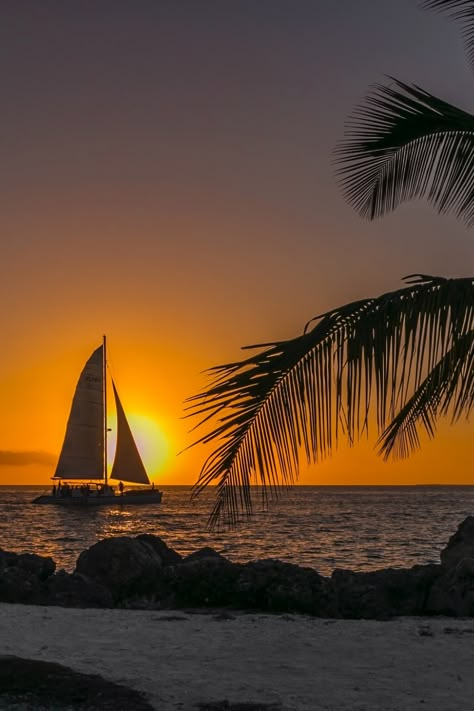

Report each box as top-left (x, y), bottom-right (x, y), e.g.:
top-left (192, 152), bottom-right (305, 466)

top-left (0, 0), bottom-right (474, 484)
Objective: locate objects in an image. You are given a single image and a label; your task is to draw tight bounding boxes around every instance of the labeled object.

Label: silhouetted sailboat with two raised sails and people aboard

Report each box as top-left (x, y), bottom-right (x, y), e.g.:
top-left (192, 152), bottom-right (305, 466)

top-left (33, 336), bottom-right (163, 506)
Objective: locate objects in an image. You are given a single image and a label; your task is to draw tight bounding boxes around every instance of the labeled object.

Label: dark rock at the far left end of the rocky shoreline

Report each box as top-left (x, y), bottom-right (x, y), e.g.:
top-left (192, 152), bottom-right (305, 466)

top-left (0, 550), bottom-right (56, 604)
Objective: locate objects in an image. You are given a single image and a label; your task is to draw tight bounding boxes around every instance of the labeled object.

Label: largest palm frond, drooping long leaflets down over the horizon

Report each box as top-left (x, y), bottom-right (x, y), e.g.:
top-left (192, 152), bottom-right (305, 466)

top-left (187, 275), bottom-right (474, 527)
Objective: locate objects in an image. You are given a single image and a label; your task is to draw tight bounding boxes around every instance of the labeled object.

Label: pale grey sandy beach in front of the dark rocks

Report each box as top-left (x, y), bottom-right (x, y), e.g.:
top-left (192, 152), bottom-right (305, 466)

top-left (0, 604), bottom-right (474, 711)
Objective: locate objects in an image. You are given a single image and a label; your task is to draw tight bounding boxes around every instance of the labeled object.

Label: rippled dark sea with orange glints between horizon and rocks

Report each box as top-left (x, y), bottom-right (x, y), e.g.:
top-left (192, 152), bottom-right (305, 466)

top-left (0, 486), bottom-right (474, 575)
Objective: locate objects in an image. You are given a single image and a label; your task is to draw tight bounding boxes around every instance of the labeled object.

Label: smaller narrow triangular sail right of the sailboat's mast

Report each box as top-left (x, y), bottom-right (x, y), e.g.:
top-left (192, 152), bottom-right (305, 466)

top-left (110, 380), bottom-right (150, 484)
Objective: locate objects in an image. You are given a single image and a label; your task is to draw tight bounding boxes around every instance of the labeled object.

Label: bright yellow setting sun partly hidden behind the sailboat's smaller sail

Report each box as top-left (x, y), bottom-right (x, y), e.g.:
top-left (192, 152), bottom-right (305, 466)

top-left (107, 412), bottom-right (170, 479)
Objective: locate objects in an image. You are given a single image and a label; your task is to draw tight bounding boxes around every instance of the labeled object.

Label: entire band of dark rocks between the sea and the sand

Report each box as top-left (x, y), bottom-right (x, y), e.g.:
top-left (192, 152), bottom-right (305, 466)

top-left (0, 516), bottom-right (474, 620)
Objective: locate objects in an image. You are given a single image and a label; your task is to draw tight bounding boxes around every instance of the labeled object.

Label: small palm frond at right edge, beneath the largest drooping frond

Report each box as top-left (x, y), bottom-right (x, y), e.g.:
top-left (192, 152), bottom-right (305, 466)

top-left (378, 331), bottom-right (474, 459)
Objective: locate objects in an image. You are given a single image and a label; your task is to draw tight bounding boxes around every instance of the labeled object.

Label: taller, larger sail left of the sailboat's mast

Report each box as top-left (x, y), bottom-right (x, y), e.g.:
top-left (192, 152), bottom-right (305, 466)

top-left (54, 346), bottom-right (105, 479)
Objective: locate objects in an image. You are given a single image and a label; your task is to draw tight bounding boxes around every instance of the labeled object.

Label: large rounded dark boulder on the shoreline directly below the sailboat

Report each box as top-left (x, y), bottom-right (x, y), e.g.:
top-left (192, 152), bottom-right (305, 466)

top-left (74, 536), bottom-right (167, 603)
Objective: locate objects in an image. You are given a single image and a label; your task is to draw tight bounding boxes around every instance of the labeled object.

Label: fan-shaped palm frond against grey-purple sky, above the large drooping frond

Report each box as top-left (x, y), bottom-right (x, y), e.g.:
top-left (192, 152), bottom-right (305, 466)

top-left (335, 79), bottom-right (474, 224)
